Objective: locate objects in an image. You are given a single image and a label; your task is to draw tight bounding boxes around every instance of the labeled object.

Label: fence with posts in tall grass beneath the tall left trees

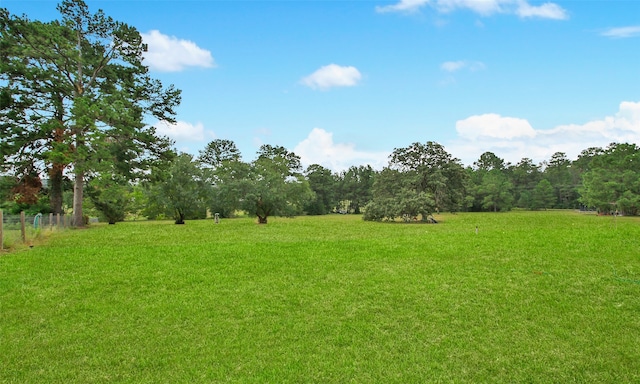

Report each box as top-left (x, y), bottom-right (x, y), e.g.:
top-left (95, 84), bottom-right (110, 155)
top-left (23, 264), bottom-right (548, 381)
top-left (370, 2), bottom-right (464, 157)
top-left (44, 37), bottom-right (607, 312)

top-left (0, 210), bottom-right (71, 250)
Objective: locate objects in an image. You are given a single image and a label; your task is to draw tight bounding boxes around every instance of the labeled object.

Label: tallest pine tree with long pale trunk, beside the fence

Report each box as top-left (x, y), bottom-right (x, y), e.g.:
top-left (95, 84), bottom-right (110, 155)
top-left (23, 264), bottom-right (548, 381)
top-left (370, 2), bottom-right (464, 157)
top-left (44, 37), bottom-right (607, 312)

top-left (0, 0), bottom-right (180, 225)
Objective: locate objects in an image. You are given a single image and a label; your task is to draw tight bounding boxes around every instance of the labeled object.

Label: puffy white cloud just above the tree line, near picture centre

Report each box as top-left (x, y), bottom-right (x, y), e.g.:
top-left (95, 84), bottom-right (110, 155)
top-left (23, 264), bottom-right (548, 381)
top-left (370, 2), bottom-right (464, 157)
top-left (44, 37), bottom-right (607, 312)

top-left (293, 128), bottom-right (389, 172)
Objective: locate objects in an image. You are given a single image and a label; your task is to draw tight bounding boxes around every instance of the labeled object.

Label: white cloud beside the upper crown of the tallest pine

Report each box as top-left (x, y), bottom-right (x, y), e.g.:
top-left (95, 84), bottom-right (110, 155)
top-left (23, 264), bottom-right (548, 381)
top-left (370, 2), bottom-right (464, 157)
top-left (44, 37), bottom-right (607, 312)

top-left (141, 30), bottom-right (216, 72)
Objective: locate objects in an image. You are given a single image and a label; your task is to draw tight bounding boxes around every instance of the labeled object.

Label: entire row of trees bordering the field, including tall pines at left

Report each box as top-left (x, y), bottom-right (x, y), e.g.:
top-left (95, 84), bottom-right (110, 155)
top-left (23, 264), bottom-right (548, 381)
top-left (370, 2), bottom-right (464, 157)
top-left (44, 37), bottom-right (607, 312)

top-left (0, 0), bottom-right (640, 226)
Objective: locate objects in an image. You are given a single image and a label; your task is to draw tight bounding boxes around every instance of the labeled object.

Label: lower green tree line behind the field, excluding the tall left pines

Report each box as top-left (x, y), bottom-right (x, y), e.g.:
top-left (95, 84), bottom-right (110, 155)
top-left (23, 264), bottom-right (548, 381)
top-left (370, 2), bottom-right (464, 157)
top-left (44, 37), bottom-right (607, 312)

top-left (0, 132), bottom-right (640, 224)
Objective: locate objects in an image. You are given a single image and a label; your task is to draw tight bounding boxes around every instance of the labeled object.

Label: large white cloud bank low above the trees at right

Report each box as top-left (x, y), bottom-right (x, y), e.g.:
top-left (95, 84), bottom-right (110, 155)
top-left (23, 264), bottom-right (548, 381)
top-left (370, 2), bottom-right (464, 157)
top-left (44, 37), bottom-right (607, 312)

top-left (447, 101), bottom-right (640, 165)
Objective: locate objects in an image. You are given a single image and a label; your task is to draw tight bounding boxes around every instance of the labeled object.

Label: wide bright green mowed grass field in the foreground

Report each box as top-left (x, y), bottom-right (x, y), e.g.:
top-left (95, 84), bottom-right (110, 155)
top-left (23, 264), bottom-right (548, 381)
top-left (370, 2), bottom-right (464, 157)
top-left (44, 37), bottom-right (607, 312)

top-left (0, 211), bottom-right (640, 383)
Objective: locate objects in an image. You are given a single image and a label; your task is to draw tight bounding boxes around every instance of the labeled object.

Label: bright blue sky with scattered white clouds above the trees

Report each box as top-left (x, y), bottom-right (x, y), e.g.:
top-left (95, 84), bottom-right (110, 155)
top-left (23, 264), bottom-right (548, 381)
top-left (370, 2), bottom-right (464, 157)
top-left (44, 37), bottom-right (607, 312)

top-left (0, 0), bottom-right (640, 171)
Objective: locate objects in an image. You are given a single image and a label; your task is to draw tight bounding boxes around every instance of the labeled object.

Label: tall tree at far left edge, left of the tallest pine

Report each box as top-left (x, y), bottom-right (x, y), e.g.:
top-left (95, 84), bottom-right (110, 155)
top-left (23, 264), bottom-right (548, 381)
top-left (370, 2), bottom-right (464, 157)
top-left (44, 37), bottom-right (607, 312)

top-left (0, 9), bottom-right (72, 213)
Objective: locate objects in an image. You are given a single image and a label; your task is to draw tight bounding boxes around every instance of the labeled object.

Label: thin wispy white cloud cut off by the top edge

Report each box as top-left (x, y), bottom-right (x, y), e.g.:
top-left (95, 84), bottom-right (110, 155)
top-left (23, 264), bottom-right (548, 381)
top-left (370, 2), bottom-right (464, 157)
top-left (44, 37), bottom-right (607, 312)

top-left (376, 0), bottom-right (568, 20)
